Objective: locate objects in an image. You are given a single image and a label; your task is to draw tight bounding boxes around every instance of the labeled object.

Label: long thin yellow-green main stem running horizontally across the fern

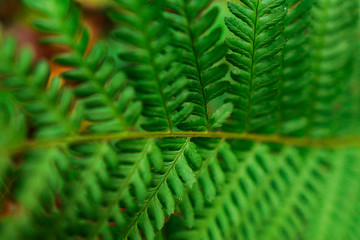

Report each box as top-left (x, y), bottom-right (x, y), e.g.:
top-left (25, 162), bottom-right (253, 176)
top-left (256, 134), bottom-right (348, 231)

top-left (6, 131), bottom-right (360, 152)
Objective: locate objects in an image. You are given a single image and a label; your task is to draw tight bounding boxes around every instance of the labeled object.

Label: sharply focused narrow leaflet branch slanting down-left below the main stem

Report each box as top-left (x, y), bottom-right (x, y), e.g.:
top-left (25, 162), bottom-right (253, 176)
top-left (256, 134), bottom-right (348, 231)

top-left (124, 138), bottom-right (202, 239)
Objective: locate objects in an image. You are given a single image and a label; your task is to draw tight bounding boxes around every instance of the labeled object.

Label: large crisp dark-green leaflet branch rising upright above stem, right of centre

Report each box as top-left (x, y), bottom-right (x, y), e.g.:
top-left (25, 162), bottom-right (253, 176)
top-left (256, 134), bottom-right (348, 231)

top-left (225, 0), bottom-right (287, 132)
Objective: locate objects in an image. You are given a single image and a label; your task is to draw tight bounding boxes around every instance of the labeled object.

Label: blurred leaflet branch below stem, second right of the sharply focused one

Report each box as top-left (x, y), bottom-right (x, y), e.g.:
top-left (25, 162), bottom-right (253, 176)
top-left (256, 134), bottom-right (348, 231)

top-left (165, 144), bottom-right (257, 239)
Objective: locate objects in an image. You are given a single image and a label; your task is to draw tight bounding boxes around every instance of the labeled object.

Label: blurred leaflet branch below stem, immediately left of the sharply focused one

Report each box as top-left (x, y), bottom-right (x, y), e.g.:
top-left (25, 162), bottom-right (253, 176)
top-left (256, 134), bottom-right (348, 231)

top-left (69, 139), bottom-right (158, 239)
